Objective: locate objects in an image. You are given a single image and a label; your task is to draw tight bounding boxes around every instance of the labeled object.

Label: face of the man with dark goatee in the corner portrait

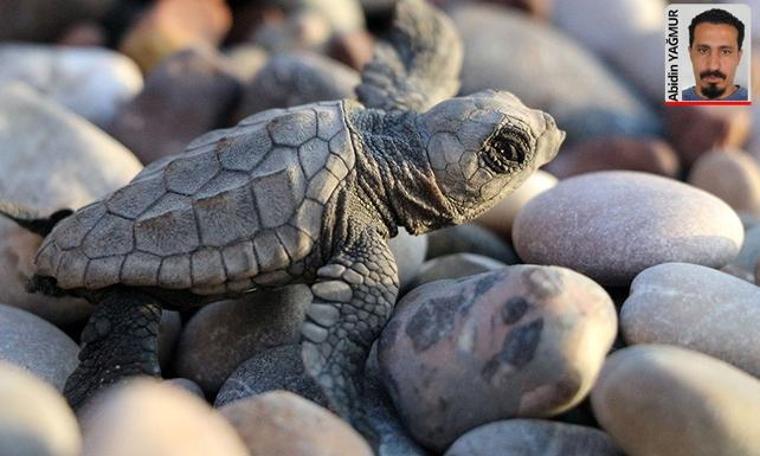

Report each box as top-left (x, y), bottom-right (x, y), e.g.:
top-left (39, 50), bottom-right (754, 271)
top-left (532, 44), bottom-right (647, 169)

top-left (689, 22), bottom-right (742, 98)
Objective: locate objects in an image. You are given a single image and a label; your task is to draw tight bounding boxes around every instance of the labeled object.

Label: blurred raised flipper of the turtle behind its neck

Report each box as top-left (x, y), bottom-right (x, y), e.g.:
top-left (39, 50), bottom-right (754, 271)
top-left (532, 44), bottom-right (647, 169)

top-left (356, 0), bottom-right (462, 112)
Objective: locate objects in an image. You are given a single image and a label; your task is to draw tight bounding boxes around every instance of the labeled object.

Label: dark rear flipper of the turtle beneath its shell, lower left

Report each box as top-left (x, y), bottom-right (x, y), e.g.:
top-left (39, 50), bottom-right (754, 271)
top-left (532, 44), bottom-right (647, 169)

top-left (63, 288), bottom-right (161, 409)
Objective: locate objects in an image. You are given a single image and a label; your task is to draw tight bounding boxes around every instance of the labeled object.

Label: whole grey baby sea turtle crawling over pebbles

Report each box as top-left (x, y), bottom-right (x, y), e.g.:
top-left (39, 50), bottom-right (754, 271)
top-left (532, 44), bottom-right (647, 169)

top-left (3, 0), bottom-right (565, 434)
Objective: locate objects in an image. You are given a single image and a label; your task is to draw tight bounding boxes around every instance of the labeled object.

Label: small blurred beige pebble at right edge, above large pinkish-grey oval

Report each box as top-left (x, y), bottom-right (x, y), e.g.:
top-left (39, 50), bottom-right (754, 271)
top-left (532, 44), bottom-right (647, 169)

top-left (689, 150), bottom-right (760, 215)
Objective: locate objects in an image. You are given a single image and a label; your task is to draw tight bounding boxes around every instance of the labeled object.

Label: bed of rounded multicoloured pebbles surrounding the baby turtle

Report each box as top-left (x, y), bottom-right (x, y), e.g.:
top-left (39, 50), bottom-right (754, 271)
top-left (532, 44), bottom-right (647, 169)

top-left (0, 0), bottom-right (760, 456)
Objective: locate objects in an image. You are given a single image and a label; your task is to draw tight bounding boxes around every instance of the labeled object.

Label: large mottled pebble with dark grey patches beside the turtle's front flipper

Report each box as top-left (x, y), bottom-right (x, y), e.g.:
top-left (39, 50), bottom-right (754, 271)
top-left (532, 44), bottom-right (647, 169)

top-left (378, 265), bottom-right (617, 451)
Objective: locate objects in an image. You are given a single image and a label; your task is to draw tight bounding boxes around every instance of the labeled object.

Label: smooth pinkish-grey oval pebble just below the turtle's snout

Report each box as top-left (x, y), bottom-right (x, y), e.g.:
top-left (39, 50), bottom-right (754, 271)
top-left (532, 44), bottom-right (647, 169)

top-left (513, 171), bottom-right (744, 286)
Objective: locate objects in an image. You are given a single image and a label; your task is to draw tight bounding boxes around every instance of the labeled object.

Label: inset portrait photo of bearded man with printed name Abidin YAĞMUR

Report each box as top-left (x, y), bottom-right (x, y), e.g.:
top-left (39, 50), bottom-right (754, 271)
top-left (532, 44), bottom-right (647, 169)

top-left (665, 3), bottom-right (752, 105)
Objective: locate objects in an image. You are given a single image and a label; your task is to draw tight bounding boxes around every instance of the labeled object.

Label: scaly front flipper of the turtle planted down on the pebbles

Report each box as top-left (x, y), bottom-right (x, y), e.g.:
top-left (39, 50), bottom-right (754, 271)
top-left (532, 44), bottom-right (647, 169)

top-left (301, 231), bottom-right (398, 435)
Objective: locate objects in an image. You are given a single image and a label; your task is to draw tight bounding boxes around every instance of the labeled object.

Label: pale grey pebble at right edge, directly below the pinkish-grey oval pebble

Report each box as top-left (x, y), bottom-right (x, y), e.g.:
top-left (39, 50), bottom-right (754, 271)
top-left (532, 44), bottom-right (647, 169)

top-left (620, 263), bottom-right (760, 377)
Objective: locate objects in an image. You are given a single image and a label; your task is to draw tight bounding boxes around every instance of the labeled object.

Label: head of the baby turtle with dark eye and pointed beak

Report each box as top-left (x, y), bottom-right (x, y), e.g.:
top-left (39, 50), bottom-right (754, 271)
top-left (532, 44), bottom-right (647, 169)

top-left (419, 90), bottom-right (565, 223)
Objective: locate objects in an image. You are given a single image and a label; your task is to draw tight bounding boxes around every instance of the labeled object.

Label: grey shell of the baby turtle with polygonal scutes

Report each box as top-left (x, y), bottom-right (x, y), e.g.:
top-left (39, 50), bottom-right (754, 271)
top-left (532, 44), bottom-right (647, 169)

top-left (36, 101), bottom-right (354, 294)
